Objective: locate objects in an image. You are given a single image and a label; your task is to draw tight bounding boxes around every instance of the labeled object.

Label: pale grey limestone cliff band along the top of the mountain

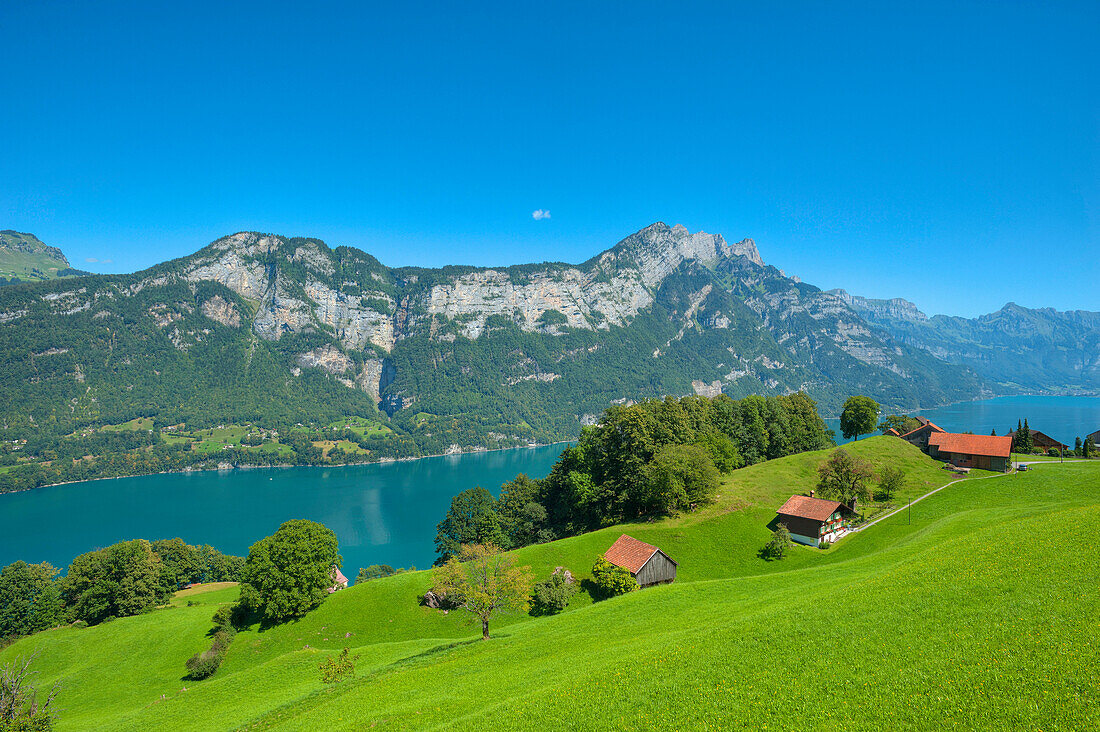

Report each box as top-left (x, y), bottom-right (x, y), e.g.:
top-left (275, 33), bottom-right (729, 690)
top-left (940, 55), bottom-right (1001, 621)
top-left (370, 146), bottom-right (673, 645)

top-left (173, 223), bottom-right (762, 352)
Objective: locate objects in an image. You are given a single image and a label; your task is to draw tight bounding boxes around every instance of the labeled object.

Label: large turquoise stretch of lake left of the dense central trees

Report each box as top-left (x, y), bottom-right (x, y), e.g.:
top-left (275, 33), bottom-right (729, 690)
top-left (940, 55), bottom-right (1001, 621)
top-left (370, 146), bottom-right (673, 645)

top-left (0, 445), bottom-right (565, 581)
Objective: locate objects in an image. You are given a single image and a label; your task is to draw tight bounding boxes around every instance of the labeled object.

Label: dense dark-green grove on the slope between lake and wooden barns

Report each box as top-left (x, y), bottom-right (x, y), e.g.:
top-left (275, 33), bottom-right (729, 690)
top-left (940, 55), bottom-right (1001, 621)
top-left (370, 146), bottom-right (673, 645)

top-left (436, 393), bottom-right (833, 564)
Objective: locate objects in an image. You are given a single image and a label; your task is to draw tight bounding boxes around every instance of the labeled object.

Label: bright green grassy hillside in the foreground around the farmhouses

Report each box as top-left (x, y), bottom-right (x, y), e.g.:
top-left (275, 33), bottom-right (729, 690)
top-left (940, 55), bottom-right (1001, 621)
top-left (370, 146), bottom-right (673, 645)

top-left (0, 438), bottom-right (1100, 730)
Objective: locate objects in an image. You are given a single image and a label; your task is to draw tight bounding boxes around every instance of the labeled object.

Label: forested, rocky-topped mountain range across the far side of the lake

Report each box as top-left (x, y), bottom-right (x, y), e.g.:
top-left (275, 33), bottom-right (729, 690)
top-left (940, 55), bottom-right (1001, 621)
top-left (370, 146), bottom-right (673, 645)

top-left (0, 223), bottom-right (1100, 447)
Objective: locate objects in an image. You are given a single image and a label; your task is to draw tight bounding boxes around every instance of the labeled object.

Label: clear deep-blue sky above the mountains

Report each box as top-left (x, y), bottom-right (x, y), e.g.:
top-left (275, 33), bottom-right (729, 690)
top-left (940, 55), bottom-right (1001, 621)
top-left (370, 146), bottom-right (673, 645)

top-left (0, 0), bottom-right (1100, 315)
